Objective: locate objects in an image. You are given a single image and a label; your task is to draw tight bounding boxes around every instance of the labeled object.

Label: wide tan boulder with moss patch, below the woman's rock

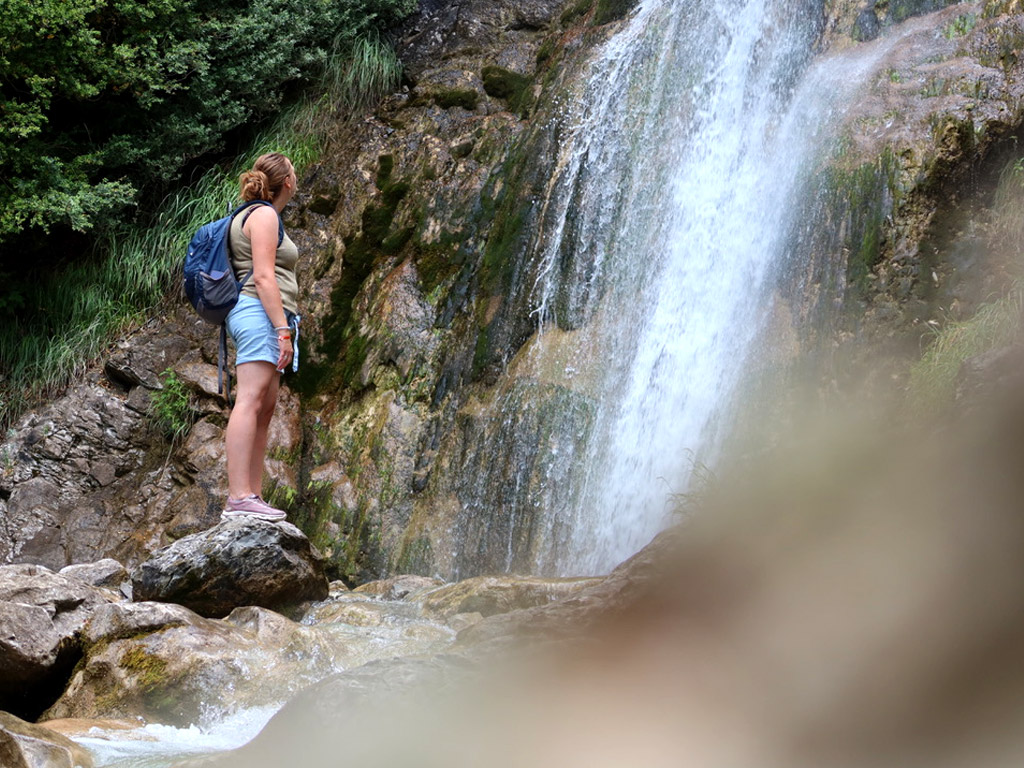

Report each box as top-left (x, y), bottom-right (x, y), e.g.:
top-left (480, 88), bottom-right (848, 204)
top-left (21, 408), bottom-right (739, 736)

top-left (42, 603), bottom-right (338, 726)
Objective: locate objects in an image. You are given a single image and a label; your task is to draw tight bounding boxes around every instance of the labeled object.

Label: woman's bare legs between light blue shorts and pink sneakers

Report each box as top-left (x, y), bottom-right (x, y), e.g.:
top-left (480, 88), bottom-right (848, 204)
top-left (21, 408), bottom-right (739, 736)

top-left (225, 361), bottom-right (281, 499)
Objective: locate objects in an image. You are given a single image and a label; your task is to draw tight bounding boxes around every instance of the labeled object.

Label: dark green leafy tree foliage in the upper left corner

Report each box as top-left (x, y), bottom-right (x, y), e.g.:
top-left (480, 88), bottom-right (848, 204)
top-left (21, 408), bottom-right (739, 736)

top-left (0, 0), bottom-right (416, 243)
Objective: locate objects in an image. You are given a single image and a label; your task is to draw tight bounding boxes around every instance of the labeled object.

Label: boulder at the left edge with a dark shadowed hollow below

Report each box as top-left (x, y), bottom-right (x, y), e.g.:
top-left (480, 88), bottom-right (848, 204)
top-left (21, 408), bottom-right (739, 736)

top-left (0, 565), bottom-right (116, 719)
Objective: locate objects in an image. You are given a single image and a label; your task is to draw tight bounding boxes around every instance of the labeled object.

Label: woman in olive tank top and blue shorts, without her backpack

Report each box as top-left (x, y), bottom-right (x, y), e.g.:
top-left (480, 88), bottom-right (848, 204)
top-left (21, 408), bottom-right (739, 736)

top-left (221, 153), bottom-right (298, 520)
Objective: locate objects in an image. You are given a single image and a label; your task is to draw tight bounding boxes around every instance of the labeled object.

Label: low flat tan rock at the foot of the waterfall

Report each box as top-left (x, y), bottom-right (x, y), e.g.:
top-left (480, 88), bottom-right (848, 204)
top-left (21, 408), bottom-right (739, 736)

top-left (423, 577), bottom-right (602, 618)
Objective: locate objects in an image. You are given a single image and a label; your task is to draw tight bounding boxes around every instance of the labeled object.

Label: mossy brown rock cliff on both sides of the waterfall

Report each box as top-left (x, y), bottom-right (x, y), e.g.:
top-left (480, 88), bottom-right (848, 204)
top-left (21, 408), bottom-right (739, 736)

top-left (0, 0), bottom-right (1024, 581)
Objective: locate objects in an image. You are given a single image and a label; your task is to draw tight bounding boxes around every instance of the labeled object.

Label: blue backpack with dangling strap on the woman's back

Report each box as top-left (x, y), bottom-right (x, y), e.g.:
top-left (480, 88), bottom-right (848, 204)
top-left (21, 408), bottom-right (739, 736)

top-left (184, 200), bottom-right (285, 397)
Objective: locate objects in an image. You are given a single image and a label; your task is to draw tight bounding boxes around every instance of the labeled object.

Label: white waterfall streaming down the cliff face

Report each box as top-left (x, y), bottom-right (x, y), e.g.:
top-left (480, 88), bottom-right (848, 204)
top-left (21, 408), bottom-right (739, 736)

top-left (505, 0), bottom-right (888, 573)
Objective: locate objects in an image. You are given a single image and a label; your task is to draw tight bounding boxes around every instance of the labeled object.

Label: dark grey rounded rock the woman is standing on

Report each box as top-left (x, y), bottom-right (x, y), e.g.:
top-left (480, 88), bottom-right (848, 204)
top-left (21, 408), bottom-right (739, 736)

top-left (132, 518), bottom-right (328, 617)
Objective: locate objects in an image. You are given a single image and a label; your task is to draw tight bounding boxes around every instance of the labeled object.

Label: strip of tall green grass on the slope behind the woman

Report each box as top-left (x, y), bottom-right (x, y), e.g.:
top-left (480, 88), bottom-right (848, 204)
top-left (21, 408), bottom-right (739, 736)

top-left (0, 38), bottom-right (400, 427)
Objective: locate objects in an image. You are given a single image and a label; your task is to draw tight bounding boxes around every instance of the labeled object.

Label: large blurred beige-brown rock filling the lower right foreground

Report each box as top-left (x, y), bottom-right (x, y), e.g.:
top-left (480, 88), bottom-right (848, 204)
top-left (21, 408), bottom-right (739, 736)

top-left (182, 397), bottom-right (1024, 768)
